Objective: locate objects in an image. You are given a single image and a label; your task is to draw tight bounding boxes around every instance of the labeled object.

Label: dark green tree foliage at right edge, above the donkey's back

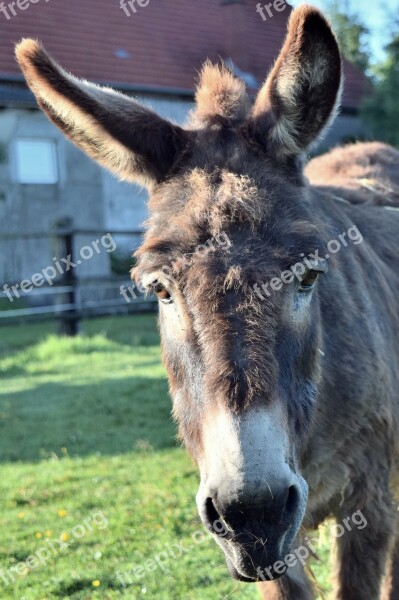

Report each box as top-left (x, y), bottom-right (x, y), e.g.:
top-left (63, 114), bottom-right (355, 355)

top-left (362, 34), bottom-right (399, 147)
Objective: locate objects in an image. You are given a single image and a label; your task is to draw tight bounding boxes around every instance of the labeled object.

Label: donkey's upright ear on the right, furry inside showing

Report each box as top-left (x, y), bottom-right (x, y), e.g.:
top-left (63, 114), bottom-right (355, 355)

top-left (251, 5), bottom-right (342, 157)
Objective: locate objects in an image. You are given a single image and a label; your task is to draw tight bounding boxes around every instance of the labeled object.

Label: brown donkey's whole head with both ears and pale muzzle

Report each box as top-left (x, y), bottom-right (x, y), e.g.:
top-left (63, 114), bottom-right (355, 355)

top-left (17, 6), bottom-right (341, 581)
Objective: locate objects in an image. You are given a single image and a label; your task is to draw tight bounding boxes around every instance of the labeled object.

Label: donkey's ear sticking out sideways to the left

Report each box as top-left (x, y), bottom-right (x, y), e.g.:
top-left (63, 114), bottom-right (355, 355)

top-left (16, 39), bottom-right (188, 185)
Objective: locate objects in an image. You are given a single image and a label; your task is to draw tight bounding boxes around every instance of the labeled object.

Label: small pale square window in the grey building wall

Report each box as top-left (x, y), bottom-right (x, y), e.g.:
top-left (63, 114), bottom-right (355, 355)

top-left (16, 138), bottom-right (58, 184)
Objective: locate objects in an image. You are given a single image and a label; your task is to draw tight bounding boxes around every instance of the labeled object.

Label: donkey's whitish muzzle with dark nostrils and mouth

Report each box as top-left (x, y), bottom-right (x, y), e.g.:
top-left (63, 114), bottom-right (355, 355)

top-left (197, 407), bottom-right (308, 582)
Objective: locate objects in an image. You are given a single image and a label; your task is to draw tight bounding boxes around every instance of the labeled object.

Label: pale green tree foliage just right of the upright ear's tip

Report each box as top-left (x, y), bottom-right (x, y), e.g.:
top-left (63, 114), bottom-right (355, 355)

top-left (327, 0), bottom-right (370, 73)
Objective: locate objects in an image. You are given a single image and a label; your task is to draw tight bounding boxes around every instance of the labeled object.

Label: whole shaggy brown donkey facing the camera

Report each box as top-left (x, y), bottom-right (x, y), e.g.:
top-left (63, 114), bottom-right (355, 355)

top-left (16, 5), bottom-right (399, 600)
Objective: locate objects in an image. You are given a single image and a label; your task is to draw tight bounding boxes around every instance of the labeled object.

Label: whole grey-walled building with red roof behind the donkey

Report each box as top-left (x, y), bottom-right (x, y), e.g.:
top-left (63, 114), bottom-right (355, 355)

top-left (0, 0), bottom-right (365, 282)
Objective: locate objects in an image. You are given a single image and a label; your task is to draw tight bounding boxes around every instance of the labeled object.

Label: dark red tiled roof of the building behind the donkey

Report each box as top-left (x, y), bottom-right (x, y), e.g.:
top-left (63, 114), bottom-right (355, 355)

top-left (0, 0), bottom-right (365, 108)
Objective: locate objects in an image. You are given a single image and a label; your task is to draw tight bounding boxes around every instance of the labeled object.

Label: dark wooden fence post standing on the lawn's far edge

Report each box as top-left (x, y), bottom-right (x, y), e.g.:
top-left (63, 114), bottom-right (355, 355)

top-left (59, 229), bottom-right (79, 336)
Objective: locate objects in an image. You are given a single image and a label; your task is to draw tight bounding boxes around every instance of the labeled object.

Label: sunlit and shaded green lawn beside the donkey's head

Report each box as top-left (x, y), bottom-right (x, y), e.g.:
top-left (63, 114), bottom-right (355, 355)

top-left (0, 315), bottom-right (332, 600)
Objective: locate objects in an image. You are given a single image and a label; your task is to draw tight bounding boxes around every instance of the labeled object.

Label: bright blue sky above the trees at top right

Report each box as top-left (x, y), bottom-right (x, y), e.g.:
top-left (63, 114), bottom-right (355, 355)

top-left (289, 0), bottom-right (399, 62)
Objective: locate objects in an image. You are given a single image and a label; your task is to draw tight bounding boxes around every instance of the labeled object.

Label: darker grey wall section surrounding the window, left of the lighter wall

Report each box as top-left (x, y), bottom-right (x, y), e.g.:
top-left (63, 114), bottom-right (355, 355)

top-left (0, 109), bottom-right (109, 282)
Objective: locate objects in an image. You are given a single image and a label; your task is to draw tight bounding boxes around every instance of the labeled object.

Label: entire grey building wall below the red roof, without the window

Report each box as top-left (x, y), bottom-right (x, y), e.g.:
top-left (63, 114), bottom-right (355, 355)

top-left (0, 96), bottom-right (367, 284)
